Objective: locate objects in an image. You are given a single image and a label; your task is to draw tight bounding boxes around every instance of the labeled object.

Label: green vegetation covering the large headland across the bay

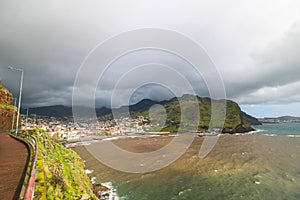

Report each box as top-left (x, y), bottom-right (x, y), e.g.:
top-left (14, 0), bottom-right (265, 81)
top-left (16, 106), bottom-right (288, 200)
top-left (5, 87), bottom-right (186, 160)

top-left (132, 95), bottom-right (252, 133)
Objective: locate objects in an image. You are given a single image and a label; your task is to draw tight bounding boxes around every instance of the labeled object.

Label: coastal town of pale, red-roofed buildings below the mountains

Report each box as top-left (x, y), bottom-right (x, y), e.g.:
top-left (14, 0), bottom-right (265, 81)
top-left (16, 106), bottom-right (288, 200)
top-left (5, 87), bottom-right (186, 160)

top-left (21, 114), bottom-right (156, 141)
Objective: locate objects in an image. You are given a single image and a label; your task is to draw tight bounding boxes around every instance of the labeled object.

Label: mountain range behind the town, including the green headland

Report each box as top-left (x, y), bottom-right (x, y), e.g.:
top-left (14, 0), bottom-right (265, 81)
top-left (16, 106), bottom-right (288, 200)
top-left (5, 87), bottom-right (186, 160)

top-left (22, 95), bottom-right (261, 133)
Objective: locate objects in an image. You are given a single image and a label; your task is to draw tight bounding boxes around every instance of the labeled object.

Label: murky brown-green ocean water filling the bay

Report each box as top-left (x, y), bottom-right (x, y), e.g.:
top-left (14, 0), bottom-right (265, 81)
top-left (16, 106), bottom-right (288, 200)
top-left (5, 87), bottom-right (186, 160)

top-left (74, 124), bottom-right (300, 200)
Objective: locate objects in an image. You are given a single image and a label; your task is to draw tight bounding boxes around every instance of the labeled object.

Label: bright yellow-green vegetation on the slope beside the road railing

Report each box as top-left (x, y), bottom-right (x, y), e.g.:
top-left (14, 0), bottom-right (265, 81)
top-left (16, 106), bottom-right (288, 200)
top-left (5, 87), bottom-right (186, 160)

top-left (27, 129), bottom-right (97, 200)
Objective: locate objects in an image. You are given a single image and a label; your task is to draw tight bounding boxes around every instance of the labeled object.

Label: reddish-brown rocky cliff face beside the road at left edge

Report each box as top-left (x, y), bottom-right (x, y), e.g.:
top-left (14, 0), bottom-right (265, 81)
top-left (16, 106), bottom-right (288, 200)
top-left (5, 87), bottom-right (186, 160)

top-left (0, 82), bottom-right (17, 131)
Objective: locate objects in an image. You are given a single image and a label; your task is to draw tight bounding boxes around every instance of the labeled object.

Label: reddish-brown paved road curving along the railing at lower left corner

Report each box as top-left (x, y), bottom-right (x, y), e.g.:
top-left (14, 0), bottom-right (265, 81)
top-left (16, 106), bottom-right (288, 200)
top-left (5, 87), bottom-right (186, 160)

top-left (0, 133), bottom-right (28, 200)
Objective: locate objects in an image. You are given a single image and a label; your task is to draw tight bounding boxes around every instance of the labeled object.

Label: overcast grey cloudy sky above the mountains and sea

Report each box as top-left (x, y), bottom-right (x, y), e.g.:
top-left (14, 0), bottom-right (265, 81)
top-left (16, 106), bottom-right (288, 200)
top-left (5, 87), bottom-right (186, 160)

top-left (0, 0), bottom-right (300, 117)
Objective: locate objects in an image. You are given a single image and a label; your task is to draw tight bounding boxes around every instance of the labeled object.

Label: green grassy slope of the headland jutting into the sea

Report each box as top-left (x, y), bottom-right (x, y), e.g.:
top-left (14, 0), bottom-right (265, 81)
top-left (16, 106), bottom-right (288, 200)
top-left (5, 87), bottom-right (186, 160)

top-left (133, 95), bottom-right (250, 132)
